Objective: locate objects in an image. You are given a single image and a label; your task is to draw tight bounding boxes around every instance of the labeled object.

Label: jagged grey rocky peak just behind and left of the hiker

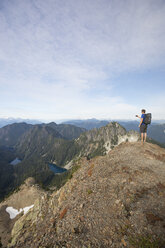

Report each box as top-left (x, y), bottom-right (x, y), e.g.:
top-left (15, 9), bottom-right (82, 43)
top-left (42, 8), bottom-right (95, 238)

top-left (76, 122), bottom-right (139, 157)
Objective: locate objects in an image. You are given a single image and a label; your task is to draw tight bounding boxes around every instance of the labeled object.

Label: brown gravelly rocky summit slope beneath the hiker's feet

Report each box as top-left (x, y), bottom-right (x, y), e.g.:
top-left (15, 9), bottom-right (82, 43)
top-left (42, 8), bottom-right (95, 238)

top-left (8, 142), bottom-right (165, 248)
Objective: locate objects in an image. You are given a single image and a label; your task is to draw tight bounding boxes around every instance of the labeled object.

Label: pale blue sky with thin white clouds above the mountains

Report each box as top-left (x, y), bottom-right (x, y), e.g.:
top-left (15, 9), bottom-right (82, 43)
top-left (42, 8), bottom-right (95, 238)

top-left (0, 0), bottom-right (165, 120)
